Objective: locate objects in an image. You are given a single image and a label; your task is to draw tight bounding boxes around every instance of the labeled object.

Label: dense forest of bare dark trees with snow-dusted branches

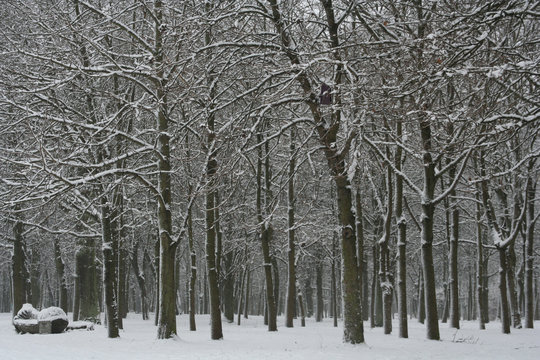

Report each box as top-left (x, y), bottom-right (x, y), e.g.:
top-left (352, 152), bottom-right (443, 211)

top-left (0, 0), bottom-right (540, 344)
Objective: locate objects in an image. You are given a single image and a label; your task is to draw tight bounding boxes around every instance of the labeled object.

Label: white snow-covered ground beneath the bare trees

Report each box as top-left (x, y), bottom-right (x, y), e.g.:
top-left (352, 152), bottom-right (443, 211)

top-left (0, 314), bottom-right (540, 360)
